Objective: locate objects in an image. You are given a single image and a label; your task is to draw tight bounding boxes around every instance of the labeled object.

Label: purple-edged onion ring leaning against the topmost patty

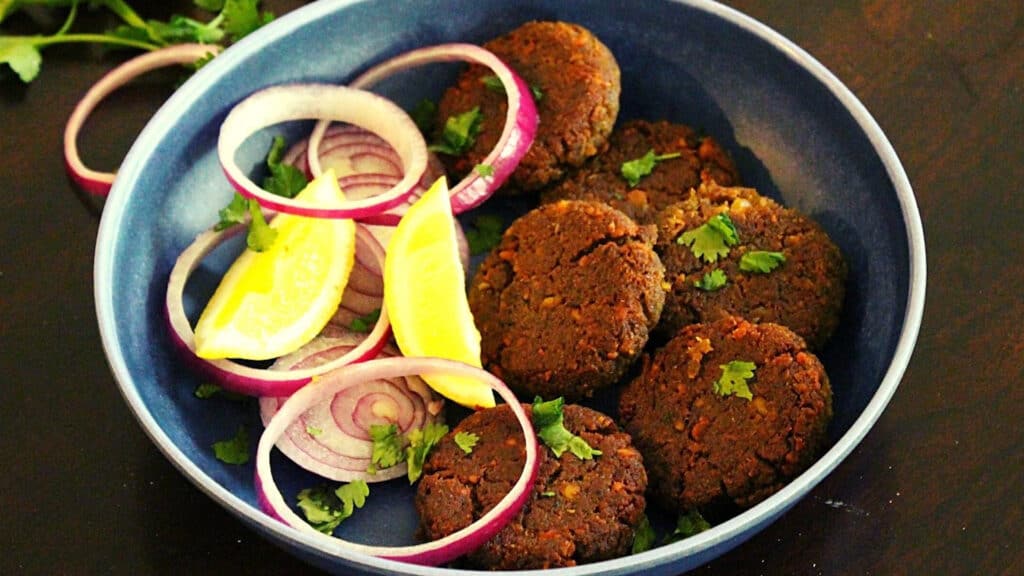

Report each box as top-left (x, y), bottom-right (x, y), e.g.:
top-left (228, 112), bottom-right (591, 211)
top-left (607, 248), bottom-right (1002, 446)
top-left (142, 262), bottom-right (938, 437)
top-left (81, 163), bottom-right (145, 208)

top-left (307, 43), bottom-right (538, 214)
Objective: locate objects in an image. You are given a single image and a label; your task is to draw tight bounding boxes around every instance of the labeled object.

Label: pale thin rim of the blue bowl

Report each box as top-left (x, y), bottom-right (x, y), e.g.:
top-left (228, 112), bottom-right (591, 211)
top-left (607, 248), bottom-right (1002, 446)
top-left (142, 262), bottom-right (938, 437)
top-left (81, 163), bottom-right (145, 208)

top-left (93, 0), bottom-right (927, 576)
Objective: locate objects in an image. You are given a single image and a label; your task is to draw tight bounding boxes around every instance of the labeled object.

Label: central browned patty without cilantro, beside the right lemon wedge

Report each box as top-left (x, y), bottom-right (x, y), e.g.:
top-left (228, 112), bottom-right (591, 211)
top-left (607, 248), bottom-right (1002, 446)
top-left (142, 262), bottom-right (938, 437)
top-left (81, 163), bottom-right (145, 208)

top-left (469, 201), bottom-right (665, 400)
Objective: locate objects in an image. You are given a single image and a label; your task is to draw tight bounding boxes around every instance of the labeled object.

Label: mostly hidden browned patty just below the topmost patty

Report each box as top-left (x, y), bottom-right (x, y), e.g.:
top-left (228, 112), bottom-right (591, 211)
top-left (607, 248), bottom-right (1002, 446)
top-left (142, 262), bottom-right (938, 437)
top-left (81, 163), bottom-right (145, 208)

top-left (541, 120), bottom-right (739, 222)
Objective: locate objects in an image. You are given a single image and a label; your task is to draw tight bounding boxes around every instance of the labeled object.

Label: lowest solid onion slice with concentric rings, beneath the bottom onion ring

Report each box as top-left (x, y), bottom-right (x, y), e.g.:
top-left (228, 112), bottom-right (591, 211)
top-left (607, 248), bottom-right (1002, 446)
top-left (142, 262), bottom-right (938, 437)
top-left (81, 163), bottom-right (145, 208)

top-left (259, 331), bottom-right (444, 483)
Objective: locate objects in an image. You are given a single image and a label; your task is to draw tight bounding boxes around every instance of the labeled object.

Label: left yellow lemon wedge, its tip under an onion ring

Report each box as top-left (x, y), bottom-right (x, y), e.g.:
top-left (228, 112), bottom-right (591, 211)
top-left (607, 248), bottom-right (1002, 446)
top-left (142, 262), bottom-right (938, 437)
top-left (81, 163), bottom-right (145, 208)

top-left (196, 170), bottom-right (355, 360)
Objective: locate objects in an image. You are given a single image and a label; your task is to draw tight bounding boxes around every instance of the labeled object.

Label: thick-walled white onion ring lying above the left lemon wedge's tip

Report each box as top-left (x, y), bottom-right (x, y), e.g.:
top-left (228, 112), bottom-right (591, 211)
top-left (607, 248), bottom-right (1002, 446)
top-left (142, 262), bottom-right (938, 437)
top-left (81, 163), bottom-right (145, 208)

top-left (217, 84), bottom-right (427, 219)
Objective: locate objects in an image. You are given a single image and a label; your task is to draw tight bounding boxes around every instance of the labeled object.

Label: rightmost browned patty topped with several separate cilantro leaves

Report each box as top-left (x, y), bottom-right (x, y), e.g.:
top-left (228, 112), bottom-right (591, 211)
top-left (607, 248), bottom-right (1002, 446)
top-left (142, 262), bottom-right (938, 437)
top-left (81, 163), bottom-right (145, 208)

top-left (655, 183), bottom-right (847, 349)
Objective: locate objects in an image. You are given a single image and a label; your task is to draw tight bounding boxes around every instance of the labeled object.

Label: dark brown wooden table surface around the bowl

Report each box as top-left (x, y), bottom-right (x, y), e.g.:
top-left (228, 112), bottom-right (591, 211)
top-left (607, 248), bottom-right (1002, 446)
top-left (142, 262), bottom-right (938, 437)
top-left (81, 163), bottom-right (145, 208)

top-left (0, 0), bottom-right (1024, 575)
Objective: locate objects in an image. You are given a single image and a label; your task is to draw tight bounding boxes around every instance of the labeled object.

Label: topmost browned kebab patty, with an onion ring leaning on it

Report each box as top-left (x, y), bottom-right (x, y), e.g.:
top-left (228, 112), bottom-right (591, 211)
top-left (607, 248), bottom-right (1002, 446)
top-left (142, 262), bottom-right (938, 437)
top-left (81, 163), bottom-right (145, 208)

top-left (437, 22), bottom-right (621, 192)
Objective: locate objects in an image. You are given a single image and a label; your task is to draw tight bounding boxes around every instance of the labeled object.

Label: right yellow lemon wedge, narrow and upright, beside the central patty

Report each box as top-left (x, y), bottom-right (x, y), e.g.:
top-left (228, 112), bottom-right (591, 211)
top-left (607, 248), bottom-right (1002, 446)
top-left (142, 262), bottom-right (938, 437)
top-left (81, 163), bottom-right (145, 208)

top-left (384, 177), bottom-right (495, 409)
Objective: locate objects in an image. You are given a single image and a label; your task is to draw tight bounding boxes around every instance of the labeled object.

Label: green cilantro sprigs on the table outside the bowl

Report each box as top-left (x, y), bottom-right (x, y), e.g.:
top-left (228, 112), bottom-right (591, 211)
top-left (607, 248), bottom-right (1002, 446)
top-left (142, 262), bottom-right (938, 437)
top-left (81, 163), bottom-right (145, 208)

top-left (0, 0), bottom-right (273, 83)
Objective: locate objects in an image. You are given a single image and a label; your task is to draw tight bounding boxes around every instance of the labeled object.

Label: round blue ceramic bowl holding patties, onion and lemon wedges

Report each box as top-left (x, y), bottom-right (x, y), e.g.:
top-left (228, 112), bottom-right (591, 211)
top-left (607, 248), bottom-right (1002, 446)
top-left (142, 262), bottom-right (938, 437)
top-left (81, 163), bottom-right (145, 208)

top-left (95, 0), bottom-right (925, 575)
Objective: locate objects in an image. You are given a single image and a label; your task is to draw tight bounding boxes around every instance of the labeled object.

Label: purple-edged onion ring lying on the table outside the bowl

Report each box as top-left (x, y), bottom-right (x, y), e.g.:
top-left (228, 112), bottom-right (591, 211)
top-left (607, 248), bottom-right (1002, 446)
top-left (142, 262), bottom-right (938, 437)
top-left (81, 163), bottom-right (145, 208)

top-left (63, 44), bottom-right (221, 196)
